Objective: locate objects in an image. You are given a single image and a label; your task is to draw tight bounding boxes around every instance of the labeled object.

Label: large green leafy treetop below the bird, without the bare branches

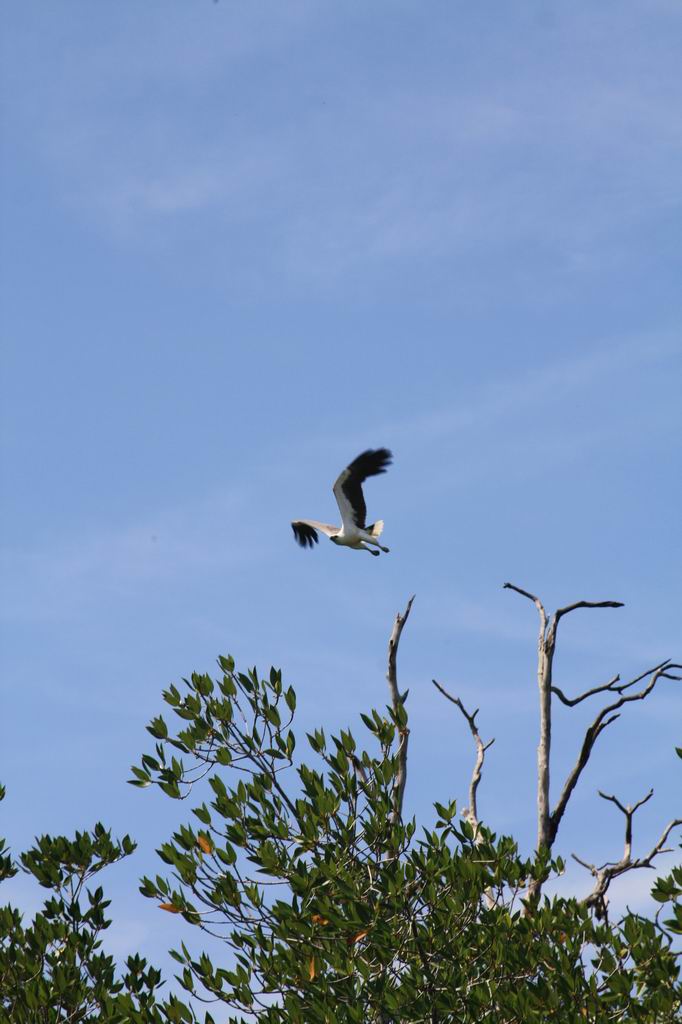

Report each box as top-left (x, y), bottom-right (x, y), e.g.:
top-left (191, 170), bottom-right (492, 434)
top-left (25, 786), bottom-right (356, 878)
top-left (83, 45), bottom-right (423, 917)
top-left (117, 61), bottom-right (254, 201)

top-left (129, 658), bottom-right (682, 1024)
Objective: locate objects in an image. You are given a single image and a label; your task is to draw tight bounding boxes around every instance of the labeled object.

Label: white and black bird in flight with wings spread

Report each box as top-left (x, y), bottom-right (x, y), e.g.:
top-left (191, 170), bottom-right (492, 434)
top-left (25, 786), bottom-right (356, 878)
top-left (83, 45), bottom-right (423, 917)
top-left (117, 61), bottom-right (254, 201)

top-left (291, 449), bottom-right (393, 555)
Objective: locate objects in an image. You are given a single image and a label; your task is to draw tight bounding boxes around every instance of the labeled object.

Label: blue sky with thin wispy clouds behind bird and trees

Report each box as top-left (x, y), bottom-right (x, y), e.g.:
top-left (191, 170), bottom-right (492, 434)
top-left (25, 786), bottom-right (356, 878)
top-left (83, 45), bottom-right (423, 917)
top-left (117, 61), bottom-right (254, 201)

top-left (0, 0), bottom-right (682, 991)
